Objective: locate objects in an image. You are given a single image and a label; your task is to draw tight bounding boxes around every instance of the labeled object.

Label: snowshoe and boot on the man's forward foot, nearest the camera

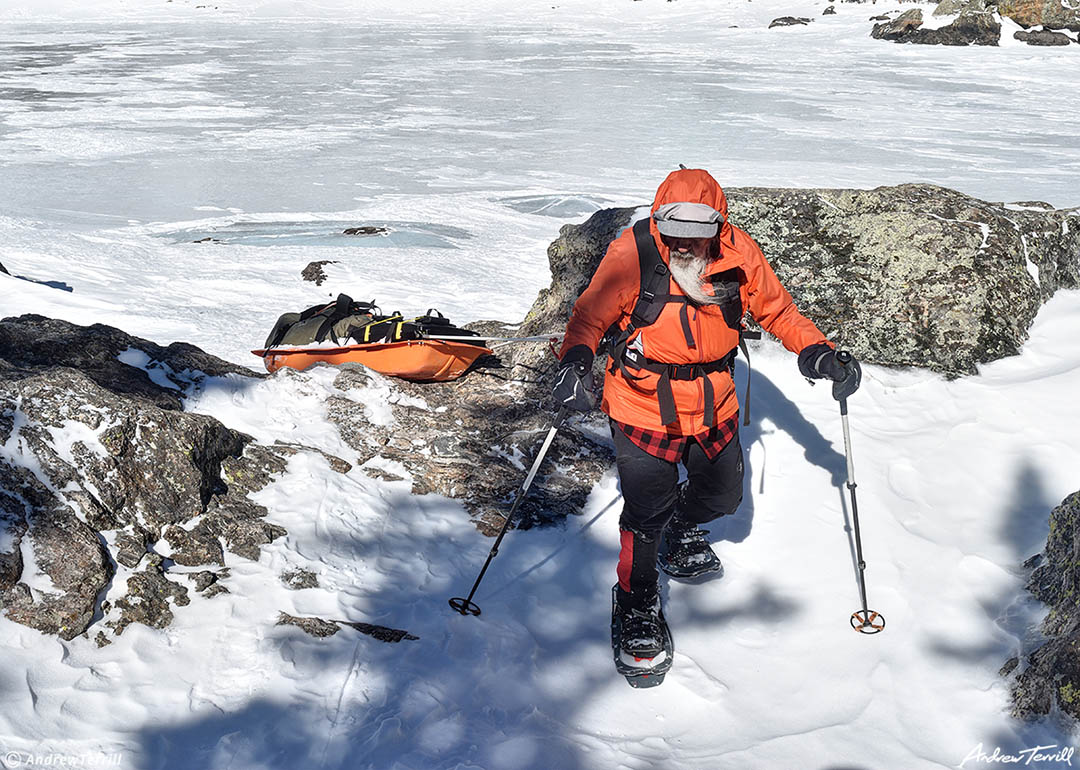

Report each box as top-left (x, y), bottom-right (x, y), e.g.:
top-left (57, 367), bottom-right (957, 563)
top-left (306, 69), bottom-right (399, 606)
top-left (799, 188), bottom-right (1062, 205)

top-left (611, 584), bottom-right (675, 688)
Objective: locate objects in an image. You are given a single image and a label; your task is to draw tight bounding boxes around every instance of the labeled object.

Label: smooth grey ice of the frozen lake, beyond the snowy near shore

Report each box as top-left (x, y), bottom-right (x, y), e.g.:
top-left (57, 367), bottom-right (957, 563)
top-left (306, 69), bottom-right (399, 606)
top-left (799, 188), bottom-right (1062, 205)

top-left (0, 19), bottom-right (1080, 220)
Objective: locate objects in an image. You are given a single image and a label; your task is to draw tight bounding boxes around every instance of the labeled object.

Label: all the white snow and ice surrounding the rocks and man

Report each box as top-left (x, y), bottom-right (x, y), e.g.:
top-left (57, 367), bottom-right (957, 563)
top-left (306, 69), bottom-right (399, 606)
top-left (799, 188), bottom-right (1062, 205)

top-left (0, 0), bottom-right (1080, 770)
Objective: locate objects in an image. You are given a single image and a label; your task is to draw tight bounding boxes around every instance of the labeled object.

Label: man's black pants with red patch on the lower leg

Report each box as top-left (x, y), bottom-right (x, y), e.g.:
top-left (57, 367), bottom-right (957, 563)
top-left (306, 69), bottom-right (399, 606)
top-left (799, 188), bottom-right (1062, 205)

top-left (611, 424), bottom-right (743, 606)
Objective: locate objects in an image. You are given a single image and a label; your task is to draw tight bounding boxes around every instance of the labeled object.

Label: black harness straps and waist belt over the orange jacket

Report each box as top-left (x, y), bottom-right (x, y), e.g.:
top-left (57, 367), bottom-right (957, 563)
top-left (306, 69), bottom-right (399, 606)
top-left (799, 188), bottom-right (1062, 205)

top-left (609, 218), bottom-right (761, 428)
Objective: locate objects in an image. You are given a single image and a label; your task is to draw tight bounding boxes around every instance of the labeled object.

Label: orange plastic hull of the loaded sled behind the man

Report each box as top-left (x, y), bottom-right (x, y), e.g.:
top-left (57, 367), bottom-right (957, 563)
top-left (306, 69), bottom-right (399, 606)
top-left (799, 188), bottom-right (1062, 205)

top-left (252, 339), bottom-right (491, 382)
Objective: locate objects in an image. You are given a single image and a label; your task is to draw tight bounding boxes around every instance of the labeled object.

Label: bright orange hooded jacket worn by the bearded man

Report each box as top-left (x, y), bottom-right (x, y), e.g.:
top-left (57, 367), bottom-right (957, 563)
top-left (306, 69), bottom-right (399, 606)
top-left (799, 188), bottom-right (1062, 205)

top-left (559, 168), bottom-right (826, 435)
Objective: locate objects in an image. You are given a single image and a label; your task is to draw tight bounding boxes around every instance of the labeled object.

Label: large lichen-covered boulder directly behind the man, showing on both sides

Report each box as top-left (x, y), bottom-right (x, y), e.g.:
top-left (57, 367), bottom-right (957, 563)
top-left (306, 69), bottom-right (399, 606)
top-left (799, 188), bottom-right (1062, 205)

top-left (531, 185), bottom-right (1080, 376)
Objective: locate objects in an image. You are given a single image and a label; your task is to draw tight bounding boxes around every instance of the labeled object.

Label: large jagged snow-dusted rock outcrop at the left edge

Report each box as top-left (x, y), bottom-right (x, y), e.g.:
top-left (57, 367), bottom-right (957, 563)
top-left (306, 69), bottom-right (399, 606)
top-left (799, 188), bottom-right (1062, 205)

top-left (0, 315), bottom-right (313, 644)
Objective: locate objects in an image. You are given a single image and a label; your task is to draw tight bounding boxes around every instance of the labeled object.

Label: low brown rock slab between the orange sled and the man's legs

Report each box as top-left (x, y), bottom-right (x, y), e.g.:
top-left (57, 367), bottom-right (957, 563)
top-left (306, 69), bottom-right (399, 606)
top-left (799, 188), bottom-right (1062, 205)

top-left (326, 362), bottom-right (610, 533)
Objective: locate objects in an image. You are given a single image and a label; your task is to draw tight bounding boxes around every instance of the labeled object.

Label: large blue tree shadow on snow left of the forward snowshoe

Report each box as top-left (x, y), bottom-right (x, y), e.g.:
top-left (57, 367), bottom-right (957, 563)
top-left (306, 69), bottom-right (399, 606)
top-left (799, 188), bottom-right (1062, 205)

top-left (128, 475), bottom-right (675, 770)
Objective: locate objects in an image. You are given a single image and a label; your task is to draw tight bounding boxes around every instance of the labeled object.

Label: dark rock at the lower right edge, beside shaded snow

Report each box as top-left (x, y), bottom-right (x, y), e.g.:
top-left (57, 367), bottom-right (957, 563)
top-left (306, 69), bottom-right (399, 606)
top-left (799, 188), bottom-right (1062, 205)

top-left (1003, 492), bottom-right (1080, 719)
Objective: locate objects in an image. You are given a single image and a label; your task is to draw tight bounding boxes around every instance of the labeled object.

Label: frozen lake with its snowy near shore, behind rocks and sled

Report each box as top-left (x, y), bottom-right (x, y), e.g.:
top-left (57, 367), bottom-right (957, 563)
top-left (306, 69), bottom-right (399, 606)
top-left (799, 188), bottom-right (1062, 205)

top-left (0, 13), bottom-right (1080, 361)
